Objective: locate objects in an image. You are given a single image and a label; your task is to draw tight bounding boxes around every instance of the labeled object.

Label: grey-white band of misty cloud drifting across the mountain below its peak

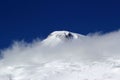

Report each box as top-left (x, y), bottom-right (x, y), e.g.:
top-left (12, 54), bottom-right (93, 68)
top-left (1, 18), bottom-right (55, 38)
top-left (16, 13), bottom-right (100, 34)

top-left (0, 30), bottom-right (120, 66)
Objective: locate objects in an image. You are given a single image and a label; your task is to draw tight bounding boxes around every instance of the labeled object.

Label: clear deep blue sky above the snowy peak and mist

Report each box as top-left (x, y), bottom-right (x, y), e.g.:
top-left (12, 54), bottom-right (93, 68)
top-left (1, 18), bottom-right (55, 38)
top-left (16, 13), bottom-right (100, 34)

top-left (0, 0), bottom-right (120, 48)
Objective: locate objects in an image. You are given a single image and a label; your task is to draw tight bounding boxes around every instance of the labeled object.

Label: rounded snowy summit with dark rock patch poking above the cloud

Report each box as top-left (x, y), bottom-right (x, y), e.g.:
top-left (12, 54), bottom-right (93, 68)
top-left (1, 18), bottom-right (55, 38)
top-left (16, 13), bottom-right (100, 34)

top-left (43, 31), bottom-right (84, 46)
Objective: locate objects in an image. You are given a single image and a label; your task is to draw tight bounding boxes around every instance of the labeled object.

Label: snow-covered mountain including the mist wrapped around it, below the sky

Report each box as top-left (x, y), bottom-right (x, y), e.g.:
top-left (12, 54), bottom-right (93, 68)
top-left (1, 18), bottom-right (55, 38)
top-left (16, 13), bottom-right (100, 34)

top-left (0, 31), bottom-right (120, 80)
